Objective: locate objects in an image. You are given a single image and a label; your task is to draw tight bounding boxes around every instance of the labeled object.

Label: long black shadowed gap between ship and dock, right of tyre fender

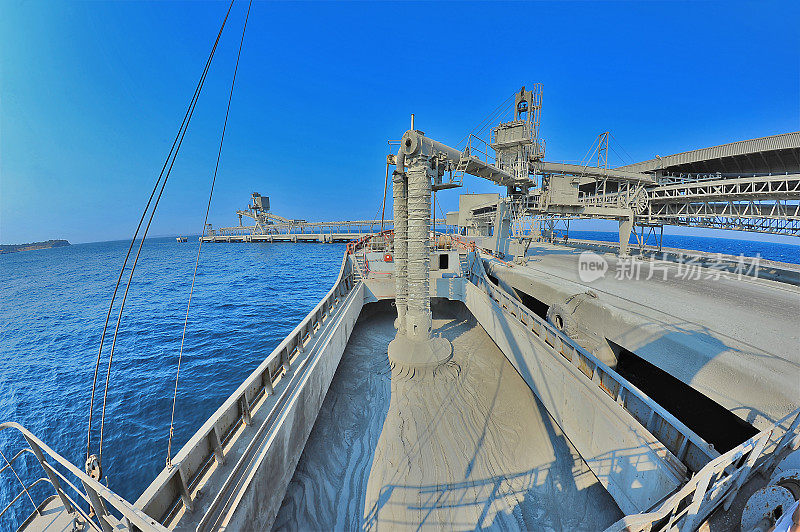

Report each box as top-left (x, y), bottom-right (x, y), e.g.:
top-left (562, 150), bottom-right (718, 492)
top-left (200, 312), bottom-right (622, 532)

top-left (608, 340), bottom-right (758, 453)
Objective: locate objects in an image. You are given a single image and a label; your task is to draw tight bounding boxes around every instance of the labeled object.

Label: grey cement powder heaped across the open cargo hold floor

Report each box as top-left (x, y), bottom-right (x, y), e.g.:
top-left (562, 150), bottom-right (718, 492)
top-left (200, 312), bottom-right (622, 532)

top-left (274, 301), bottom-right (622, 530)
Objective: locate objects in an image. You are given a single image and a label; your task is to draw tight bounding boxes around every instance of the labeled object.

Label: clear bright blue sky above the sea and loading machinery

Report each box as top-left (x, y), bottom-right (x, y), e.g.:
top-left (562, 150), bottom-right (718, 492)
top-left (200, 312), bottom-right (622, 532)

top-left (0, 0), bottom-right (800, 243)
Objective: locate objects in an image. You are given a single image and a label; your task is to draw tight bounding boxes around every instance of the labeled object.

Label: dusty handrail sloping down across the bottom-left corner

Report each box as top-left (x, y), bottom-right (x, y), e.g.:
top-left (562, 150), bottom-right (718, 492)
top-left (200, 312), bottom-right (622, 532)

top-left (0, 421), bottom-right (166, 532)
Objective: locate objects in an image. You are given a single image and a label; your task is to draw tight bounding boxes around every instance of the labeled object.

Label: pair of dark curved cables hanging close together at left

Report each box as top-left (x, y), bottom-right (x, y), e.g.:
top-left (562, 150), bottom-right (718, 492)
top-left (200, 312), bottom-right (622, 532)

top-left (86, 0), bottom-right (235, 466)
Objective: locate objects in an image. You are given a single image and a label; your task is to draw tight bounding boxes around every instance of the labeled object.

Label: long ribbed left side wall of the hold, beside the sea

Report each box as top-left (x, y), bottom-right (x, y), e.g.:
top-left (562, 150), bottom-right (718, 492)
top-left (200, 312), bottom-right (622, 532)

top-left (136, 255), bottom-right (365, 530)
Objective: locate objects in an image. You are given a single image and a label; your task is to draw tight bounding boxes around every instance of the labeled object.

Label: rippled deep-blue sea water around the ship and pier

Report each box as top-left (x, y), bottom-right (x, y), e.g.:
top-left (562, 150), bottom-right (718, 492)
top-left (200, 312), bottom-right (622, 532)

top-left (0, 231), bottom-right (800, 530)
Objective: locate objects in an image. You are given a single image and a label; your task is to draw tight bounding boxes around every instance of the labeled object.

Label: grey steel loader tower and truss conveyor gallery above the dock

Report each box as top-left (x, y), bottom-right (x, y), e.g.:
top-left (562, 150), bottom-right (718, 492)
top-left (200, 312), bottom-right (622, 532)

top-left (450, 90), bottom-right (800, 240)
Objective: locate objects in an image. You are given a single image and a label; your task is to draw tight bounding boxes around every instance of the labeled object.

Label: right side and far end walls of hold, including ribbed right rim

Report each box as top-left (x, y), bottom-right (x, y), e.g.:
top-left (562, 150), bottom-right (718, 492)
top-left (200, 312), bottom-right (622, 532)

top-left (354, 247), bottom-right (719, 513)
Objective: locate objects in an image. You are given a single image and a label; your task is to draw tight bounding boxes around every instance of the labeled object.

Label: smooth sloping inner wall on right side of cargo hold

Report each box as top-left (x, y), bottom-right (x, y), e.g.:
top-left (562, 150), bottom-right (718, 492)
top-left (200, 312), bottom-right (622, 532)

top-left (465, 283), bottom-right (682, 514)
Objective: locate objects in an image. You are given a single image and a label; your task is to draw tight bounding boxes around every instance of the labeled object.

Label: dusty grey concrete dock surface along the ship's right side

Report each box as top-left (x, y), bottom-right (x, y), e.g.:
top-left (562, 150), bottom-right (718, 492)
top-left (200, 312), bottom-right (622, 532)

top-left (485, 243), bottom-right (800, 434)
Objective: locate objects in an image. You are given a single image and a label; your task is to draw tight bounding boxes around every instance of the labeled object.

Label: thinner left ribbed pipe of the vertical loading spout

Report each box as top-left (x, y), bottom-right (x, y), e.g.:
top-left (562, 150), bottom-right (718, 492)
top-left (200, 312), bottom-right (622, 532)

top-left (392, 148), bottom-right (408, 335)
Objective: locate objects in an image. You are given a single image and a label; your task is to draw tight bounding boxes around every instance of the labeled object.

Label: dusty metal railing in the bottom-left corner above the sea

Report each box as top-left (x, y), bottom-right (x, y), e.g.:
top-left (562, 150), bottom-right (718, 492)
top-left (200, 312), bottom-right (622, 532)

top-left (0, 422), bottom-right (166, 532)
